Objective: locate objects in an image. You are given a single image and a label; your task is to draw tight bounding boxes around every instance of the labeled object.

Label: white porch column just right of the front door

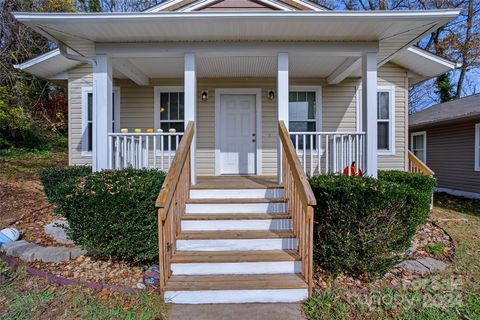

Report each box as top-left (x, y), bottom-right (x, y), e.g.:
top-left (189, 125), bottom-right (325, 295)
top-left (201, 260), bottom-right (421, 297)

top-left (277, 52), bottom-right (288, 184)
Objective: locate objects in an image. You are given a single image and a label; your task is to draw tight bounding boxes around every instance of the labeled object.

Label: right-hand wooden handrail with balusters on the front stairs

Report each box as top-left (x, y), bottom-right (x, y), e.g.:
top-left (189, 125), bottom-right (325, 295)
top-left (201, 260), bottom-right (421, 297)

top-left (278, 121), bottom-right (317, 296)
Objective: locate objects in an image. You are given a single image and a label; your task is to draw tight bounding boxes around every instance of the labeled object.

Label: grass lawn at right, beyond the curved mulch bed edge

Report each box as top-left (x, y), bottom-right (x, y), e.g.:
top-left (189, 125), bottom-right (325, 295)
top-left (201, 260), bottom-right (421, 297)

top-left (304, 194), bottom-right (480, 320)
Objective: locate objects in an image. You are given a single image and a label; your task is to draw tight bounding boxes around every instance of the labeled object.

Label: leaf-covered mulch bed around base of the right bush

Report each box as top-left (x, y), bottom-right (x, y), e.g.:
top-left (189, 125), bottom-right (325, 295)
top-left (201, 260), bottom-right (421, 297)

top-left (314, 222), bottom-right (455, 292)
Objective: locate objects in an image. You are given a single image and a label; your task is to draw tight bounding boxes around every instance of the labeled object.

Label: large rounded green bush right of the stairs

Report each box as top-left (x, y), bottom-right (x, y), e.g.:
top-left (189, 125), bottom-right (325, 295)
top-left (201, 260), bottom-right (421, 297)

top-left (310, 173), bottom-right (432, 276)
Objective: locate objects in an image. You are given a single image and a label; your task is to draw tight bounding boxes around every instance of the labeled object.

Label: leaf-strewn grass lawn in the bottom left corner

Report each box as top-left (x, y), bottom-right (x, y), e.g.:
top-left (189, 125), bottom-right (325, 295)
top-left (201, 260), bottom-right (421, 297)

top-left (0, 261), bottom-right (167, 320)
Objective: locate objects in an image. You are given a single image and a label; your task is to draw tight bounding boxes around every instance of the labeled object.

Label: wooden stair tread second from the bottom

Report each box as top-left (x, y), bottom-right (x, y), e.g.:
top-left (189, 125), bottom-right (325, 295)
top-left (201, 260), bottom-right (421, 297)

top-left (172, 250), bottom-right (300, 263)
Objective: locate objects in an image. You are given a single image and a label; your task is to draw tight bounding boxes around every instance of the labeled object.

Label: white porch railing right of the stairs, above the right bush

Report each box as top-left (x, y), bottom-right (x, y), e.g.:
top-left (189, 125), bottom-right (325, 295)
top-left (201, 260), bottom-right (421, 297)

top-left (289, 132), bottom-right (365, 176)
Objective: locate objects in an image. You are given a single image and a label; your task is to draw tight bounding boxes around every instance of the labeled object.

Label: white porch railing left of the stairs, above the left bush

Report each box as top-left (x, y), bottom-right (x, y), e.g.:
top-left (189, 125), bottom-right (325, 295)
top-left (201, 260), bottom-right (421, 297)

top-left (108, 132), bottom-right (183, 170)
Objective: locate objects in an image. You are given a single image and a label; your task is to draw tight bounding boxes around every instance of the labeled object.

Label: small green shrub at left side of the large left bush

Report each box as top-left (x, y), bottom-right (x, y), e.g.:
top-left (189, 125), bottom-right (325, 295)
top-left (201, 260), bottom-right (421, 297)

top-left (38, 166), bottom-right (92, 206)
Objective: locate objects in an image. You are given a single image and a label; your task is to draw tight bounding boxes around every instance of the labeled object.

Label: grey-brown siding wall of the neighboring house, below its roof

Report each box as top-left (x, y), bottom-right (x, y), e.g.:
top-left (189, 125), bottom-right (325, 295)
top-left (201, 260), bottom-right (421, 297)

top-left (412, 119), bottom-right (480, 193)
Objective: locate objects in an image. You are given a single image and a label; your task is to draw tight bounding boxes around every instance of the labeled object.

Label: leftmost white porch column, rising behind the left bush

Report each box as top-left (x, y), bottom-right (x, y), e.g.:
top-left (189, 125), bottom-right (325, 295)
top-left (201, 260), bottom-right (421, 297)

top-left (92, 54), bottom-right (112, 171)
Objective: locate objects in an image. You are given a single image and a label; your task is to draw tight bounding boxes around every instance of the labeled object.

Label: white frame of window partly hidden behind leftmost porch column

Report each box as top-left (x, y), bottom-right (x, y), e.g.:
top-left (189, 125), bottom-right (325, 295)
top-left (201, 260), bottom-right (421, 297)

top-left (81, 87), bottom-right (121, 157)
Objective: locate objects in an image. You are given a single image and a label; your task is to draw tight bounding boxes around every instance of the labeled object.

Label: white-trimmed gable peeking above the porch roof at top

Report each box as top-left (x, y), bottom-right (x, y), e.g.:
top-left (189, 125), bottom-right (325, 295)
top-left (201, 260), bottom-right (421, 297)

top-left (145, 0), bottom-right (330, 12)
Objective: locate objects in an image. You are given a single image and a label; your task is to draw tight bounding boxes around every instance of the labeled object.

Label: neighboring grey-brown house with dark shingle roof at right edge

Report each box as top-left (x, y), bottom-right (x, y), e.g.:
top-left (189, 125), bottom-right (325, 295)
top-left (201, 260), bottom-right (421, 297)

top-left (409, 94), bottom-right (480, 199)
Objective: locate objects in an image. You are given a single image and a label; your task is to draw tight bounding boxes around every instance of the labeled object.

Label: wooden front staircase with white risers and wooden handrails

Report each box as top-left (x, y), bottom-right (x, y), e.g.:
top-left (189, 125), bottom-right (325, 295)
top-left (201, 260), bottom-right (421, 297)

top-left (157, 124), bottom-right (314, 304)
